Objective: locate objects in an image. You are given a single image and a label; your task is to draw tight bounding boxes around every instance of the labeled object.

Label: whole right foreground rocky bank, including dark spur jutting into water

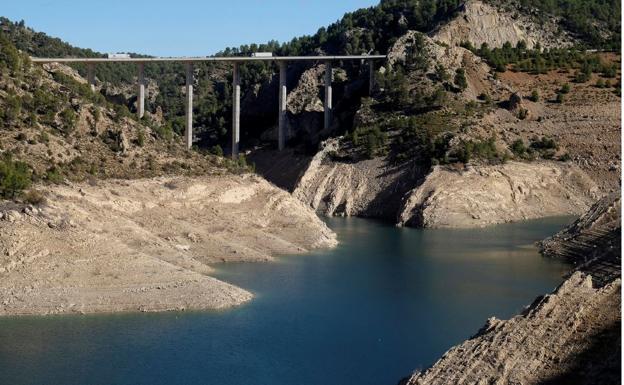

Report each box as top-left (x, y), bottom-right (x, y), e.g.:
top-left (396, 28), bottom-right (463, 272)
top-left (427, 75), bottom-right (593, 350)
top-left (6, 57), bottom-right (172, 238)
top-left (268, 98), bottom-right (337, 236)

top-left (401, 194), bottom-right (622, 385)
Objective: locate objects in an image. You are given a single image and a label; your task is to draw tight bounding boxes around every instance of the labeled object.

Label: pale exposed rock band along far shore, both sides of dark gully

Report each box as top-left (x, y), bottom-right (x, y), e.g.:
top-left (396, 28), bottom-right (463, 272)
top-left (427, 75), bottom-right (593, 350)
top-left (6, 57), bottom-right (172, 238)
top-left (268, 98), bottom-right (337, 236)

top-left (293, 139), bottom-right (597, 227)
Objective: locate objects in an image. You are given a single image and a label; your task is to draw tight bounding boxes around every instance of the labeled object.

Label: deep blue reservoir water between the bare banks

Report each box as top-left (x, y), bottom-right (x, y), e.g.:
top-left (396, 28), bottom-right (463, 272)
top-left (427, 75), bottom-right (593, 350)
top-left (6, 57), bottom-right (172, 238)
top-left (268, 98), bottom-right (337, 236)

top-left (0, 218), bottom-right (571, 385)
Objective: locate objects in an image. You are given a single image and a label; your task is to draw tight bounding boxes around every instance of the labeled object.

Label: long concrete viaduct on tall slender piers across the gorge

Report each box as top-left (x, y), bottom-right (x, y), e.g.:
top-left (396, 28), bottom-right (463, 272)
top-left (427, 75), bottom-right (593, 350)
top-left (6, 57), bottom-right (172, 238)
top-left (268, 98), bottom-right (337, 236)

top-left (31, 55), bottom-right (386, 157)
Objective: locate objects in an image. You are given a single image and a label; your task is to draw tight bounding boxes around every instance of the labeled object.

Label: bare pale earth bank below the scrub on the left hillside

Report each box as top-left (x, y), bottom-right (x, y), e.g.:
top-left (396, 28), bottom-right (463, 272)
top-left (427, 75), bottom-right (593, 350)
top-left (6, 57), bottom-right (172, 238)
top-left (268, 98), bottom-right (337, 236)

top-left (0, 175), bottom-right (336, 315)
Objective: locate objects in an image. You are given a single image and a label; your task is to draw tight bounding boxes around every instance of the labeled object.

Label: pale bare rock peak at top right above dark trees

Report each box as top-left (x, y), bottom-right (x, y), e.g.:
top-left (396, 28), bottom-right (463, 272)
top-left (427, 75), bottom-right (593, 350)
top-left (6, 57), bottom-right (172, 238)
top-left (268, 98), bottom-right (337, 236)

top-left (430, 0), bottom-right (574, 48)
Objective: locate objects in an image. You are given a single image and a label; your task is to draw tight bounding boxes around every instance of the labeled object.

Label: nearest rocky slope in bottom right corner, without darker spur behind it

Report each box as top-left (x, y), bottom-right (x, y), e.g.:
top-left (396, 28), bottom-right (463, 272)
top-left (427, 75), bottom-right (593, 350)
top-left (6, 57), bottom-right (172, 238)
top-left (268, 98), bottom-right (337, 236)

top-left (405, 272), bottom-right (621, 385)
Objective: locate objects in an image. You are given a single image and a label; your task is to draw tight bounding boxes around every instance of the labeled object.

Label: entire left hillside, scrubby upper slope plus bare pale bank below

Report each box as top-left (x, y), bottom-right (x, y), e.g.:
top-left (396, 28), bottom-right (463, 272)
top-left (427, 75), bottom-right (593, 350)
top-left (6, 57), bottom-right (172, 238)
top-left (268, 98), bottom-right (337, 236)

top-left (0, 34), bottom-right (336, 315)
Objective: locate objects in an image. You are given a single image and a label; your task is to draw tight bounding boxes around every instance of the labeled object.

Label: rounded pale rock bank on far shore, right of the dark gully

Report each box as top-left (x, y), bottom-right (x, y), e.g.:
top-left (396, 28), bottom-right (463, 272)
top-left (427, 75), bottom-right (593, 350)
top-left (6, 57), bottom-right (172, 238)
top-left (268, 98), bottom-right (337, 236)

top-left (398, 162), bottom-right (597, 227)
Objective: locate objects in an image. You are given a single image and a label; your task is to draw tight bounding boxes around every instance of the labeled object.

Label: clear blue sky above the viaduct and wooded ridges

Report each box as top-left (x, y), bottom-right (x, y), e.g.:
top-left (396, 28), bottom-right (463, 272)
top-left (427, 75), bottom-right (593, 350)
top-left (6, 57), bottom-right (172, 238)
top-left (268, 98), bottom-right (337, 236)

top-left (0, 0), bottom-right (379, 56)
